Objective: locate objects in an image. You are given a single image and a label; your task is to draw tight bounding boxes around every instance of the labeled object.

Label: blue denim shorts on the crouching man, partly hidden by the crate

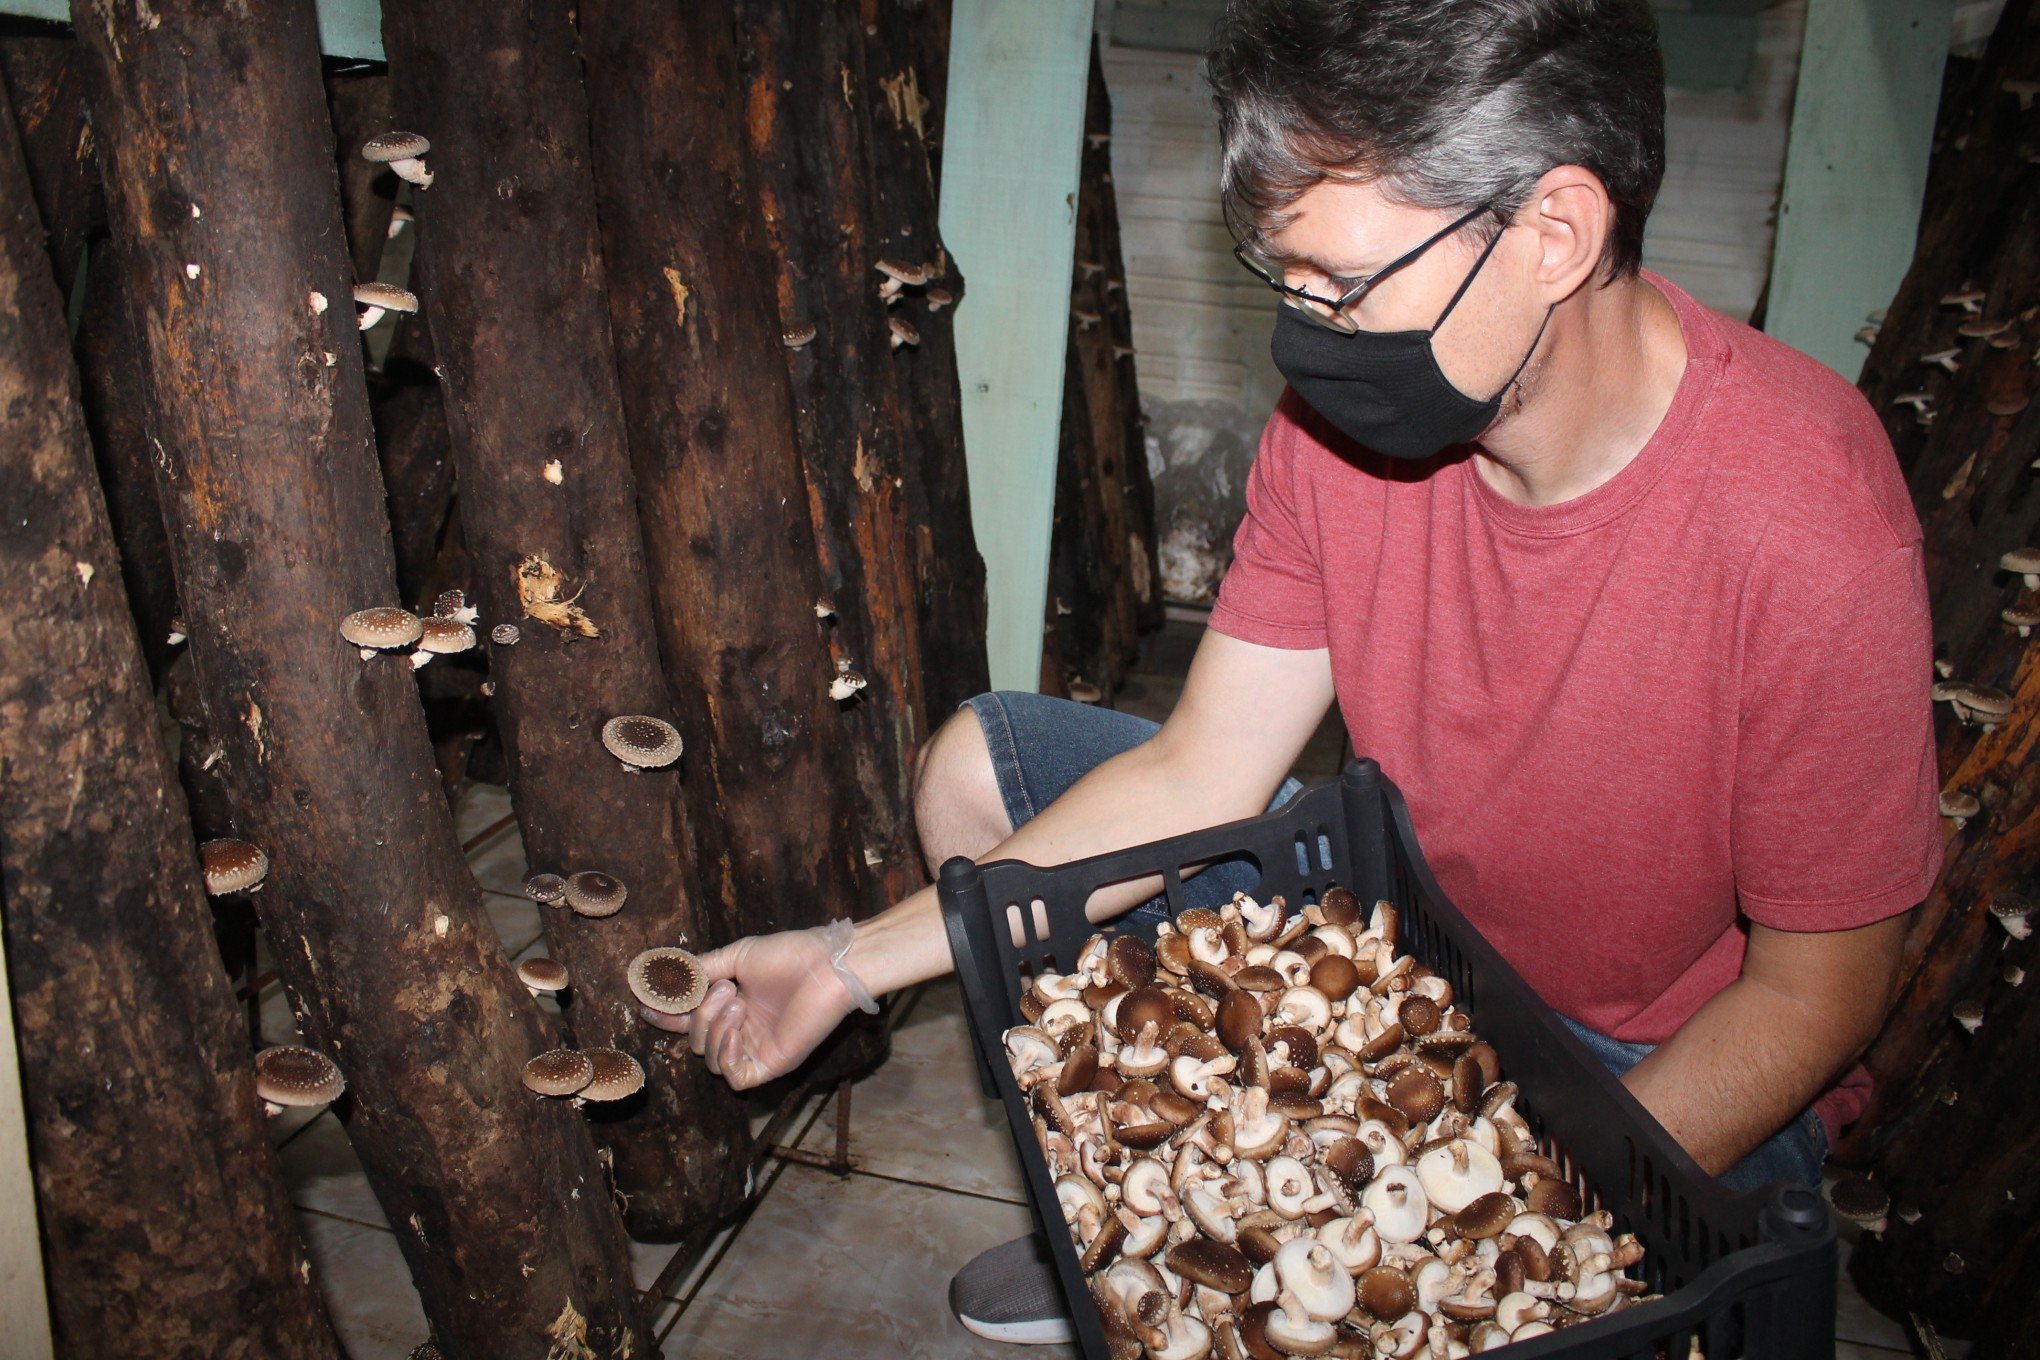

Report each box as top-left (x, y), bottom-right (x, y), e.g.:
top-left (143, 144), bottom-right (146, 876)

top-left (959, 689), bottom-right (1828, 1191)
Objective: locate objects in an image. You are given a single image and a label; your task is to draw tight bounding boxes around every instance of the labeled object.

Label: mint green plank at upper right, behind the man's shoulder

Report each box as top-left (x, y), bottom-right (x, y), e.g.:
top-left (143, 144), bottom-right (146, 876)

top-left (1765, 0), bottom-right (1954, 381)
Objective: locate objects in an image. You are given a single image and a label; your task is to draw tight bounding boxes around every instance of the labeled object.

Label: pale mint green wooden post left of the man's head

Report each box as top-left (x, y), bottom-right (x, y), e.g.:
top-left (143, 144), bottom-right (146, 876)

top-left (942, 0), bottom-right (1091, 691)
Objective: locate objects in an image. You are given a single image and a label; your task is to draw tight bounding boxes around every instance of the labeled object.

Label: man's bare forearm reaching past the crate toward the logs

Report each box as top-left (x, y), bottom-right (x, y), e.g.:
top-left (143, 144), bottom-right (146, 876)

top-left (845, 742), bottom-right (1273, 995)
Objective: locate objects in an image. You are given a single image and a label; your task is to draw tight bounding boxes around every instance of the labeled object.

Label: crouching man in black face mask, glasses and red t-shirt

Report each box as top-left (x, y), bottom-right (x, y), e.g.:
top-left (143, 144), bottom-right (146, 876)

top-left (652, 0), bottom-right (1940, 1340)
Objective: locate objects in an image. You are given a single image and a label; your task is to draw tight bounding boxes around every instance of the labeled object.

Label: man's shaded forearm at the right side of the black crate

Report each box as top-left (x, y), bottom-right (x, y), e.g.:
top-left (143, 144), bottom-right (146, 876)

top-left (1622, 977), bottom-right (1881, 1176)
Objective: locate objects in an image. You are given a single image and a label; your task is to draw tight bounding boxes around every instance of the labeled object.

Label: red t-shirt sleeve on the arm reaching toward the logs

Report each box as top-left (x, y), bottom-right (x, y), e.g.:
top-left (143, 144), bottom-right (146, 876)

top-left (1210, 408), bottom-right (1328, 650)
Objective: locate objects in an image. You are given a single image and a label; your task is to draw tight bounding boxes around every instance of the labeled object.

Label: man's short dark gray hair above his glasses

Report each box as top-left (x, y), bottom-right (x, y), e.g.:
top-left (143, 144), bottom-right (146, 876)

top-left (1206, 0), bottom-right (1665, 275)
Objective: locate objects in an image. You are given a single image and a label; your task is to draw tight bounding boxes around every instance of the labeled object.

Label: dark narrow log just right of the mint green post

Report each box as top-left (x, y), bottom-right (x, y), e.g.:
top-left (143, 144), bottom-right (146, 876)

top-left (1042, 41), bottom-right (1161, 701)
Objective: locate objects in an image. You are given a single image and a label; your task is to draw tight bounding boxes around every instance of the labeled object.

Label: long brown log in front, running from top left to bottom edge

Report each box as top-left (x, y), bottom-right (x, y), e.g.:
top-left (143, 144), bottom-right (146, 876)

top-left (78, 0), bottom-right (655, 1360)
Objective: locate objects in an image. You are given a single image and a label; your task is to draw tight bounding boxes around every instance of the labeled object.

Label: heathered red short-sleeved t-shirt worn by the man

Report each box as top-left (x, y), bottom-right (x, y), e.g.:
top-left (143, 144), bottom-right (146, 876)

top-left (1212, 273), bottom-right (1942, 1136)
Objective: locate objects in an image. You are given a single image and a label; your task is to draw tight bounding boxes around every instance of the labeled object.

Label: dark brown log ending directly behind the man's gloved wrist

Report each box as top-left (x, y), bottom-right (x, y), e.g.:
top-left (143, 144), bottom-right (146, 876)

top-left (567, 0), bottom-right (867, 944)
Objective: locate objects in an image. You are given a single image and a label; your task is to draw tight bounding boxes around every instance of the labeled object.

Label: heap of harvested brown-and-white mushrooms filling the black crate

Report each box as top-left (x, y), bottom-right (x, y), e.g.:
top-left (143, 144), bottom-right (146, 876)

top-left (1004, 887), bottom-right (1644, 1360)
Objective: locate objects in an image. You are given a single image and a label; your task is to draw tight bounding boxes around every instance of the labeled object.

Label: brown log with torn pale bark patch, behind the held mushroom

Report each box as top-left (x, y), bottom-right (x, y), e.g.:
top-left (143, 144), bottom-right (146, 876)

top-left (384, 0), bottom-right (749, 1240)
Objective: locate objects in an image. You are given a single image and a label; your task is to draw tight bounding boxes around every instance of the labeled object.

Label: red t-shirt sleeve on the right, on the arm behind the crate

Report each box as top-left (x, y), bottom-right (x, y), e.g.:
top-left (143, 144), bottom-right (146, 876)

top-left (1732, 540), bottom-right (1942, 930)
